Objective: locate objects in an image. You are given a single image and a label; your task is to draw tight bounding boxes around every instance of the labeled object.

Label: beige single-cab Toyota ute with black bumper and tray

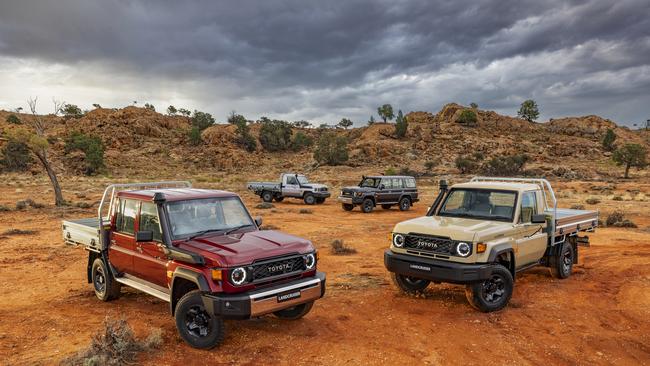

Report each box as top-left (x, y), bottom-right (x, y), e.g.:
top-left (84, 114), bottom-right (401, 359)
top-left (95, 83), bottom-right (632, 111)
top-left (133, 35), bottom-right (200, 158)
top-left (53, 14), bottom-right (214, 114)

top-left (384, 177), bottom-right (598, 312)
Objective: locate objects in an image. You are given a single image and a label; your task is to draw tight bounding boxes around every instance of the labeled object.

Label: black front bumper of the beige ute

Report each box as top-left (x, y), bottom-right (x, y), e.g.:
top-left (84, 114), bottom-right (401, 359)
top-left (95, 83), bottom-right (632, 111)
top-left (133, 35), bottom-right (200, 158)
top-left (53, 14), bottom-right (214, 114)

top-left (384, 249), bottom-right (494, 284)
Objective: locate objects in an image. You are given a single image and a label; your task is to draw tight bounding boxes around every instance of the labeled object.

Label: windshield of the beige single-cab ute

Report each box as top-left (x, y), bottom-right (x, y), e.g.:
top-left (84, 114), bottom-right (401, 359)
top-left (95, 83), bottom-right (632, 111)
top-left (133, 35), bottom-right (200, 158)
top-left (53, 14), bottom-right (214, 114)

top-left (438, 189), bottom-right (517, 221)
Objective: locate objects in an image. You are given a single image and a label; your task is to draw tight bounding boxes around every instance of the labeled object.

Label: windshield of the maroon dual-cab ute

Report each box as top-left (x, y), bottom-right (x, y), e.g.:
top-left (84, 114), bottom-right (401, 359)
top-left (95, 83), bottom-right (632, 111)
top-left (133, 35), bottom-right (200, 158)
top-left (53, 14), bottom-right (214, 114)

top-left (167, 197), bottom-right (254, 238)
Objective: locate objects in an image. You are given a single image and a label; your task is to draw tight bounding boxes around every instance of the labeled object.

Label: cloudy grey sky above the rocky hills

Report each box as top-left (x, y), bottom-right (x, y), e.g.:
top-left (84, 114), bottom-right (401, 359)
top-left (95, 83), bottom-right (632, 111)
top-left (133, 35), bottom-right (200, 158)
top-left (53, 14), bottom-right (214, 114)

top-left (0, 0), bottom-right (650, 126)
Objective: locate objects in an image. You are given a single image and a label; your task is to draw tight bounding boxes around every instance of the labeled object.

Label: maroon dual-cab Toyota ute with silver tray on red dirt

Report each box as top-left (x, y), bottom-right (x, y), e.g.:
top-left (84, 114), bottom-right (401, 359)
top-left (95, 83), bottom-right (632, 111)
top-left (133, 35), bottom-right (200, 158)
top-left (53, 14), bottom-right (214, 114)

top-left (63, 182), bottom-right (325, 348)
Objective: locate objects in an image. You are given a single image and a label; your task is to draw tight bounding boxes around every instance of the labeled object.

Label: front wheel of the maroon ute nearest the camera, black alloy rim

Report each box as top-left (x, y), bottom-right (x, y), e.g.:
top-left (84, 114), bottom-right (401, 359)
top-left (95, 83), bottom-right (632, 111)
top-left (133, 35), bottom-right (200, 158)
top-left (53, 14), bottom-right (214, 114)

top-left (174, 290), bottom-right (225, 349)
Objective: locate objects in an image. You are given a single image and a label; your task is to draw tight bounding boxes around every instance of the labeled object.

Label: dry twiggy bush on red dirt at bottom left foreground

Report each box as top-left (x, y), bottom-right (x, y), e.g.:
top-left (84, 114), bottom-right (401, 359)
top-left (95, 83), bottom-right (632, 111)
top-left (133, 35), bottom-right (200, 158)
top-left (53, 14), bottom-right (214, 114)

top-left (62, 318), bottom-right (163, 366)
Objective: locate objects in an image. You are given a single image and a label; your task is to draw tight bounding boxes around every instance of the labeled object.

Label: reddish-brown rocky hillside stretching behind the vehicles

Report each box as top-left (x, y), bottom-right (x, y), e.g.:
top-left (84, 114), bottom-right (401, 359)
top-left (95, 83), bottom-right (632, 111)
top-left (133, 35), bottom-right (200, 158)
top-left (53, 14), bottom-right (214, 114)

top-left (0, 104), bottom-right (650, 178)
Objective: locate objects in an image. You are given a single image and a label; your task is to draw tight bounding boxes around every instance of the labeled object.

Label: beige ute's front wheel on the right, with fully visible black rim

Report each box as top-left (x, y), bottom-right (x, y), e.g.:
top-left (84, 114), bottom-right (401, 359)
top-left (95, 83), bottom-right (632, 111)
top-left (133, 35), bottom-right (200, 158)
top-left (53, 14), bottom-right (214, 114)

top-left (465, 265), bottom-right (514, 313)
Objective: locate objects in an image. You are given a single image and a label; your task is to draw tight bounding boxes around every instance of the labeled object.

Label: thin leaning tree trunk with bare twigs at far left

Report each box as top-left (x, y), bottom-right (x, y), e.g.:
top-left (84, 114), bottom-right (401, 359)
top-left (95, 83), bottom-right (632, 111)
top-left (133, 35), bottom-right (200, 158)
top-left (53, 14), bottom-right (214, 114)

top-left (25, 97), bottom-right (65, 206)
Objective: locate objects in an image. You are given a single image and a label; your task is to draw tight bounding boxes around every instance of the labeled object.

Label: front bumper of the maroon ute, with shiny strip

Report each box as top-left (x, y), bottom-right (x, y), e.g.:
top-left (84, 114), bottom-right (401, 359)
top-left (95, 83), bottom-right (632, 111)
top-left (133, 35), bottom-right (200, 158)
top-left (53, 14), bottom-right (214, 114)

top-left (202, 272), bottom-right (325, 319)
